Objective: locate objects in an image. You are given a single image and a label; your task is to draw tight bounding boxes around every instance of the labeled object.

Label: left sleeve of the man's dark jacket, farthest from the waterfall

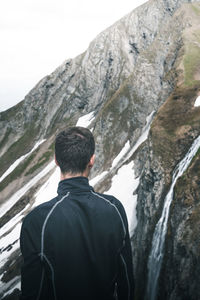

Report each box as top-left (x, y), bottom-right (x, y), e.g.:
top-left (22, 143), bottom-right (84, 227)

top-left (20, 217), bottom-right (47, 300)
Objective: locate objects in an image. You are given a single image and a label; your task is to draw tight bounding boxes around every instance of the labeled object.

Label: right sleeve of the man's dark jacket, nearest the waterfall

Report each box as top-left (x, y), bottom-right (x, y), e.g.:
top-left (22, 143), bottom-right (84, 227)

top-left (114, 203), bottom-right (134, 300)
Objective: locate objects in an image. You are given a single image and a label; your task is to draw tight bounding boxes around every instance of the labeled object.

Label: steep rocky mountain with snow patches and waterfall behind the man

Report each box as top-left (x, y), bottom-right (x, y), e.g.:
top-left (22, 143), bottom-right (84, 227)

top-left (0, 0), bottom-right (200, 300)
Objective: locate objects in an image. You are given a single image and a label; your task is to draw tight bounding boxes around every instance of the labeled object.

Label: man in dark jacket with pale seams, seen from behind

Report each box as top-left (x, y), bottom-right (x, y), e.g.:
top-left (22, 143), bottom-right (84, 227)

top-left (20, 127), bottom-right (133, 300)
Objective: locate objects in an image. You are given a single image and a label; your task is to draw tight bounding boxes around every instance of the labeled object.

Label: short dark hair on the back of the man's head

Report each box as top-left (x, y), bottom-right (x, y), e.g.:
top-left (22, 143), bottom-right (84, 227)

top-left (55, 127), bottom-right (95, 174)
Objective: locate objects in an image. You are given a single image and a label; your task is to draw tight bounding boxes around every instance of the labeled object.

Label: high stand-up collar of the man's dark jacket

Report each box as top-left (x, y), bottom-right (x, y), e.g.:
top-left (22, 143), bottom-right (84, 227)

top-left (57, 176), bottom-right (93, 195)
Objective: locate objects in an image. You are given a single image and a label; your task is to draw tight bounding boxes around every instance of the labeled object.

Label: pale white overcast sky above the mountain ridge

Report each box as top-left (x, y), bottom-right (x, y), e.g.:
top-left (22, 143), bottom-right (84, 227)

top-left (0, 0), bottom-right (147, 111)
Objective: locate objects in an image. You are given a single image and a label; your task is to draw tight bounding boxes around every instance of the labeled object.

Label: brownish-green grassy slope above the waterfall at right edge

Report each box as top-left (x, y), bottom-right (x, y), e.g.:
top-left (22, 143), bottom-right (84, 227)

top-left (151, 4), bottom-right (200, 172)
